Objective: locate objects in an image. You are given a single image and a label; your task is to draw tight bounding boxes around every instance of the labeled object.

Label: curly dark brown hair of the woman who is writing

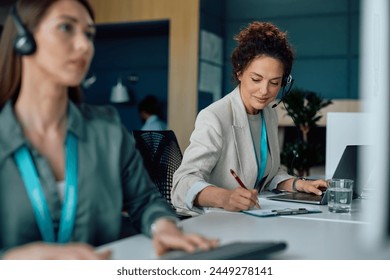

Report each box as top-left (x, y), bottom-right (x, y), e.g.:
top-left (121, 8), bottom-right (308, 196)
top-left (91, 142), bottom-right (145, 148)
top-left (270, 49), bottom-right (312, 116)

top-left (231, 21), bottom-right (294, 86)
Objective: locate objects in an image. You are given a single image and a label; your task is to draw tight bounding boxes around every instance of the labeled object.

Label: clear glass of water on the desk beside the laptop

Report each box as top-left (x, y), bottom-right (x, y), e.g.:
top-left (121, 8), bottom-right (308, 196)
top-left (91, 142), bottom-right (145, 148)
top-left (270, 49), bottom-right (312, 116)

top-left (326, 179), bottom-right (354, 213)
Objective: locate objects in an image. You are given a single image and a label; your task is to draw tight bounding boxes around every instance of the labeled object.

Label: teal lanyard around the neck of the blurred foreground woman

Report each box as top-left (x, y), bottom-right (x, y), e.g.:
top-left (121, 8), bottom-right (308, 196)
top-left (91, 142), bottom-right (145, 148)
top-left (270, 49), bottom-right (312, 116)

top-left (15, 133), bottom-right (78, 243)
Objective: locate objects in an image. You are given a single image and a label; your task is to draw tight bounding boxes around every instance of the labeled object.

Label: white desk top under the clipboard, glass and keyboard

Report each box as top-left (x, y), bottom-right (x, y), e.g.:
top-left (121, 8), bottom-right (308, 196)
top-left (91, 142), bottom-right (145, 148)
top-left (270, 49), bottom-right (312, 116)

top-left (97, 198), bottom-right (390, 259)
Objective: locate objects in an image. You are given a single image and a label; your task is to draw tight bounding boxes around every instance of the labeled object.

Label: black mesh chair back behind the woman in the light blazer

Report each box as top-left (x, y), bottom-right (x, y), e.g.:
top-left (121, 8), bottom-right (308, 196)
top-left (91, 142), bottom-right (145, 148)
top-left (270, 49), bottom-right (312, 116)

top-left (133, 130), bottom-right (183, 207)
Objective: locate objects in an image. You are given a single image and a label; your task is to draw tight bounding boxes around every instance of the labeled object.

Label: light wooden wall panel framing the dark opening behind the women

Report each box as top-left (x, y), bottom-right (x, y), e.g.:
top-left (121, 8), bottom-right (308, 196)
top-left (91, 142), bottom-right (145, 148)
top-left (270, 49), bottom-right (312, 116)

top-left (90, 0), bottom-right (200, 150)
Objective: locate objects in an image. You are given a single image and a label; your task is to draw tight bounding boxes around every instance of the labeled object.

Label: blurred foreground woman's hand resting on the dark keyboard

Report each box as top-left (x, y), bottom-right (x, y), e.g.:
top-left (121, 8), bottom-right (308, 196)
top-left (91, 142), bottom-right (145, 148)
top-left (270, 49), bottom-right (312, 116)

top-left (153, 218), bottom-right (218, 256)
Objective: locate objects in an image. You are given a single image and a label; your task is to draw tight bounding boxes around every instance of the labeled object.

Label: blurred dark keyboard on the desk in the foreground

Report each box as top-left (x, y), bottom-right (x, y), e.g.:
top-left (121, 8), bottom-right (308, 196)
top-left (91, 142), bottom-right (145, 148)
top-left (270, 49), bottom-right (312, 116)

top-left (161, 241), bottom-right (287, 260)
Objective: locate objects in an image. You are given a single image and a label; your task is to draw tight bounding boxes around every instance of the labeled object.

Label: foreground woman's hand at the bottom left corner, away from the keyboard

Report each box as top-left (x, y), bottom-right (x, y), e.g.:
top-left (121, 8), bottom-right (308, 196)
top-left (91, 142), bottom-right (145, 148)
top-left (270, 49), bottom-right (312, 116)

top-left (3, 242), bottom-right (111, 260)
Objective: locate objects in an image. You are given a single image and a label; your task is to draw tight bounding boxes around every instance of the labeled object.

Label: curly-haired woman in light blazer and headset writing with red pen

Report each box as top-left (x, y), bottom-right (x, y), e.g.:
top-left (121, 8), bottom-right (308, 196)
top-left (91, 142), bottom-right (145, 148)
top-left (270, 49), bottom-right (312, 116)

top-left (172, 21), bottom-right (326, 212)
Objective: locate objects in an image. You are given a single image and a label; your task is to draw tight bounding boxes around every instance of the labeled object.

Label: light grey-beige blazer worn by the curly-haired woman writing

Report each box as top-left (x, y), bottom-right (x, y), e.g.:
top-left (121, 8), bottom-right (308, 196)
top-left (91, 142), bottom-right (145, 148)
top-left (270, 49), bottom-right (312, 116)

top-left (171, 87), bottom-right (291, 211)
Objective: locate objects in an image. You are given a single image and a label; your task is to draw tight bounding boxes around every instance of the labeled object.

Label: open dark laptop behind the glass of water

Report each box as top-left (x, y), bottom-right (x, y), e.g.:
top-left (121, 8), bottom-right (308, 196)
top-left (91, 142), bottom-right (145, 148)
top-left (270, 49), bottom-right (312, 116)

top-left (267, 145), bottom-right (367, 205)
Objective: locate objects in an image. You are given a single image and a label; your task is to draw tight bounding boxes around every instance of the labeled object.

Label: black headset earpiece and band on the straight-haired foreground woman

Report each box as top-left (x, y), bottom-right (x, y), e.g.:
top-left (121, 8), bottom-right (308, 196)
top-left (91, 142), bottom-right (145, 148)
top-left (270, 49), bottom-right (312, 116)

top-left (11, 5), bottom-right (37, 55)
